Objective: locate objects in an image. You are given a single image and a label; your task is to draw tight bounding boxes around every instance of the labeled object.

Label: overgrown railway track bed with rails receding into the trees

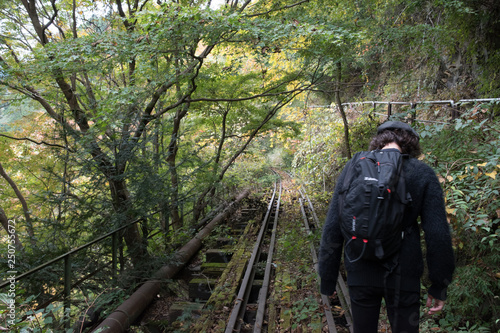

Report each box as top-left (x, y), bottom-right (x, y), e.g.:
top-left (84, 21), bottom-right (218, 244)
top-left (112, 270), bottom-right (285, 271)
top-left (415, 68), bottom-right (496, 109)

top-left (106, 172), bottom-right (352, 333)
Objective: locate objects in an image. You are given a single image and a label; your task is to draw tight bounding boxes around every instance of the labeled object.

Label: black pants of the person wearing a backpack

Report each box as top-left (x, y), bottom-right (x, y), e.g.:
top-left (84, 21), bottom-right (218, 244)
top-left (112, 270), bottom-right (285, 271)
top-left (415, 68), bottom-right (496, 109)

top-left (349, 286), bottom-right (420, 333)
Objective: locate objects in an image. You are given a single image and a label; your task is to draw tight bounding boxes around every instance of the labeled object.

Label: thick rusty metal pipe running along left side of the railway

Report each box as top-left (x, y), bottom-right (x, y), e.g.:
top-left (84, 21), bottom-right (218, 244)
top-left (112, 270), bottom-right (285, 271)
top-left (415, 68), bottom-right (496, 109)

top-left (94, 190), bottom-right (250, 333)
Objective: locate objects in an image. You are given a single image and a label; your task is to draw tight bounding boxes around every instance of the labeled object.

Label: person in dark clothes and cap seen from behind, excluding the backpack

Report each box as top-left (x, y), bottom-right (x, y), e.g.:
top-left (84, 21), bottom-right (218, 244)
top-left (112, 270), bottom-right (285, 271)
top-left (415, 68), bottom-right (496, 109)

top-left (319, 121), bottom-right (455, 333)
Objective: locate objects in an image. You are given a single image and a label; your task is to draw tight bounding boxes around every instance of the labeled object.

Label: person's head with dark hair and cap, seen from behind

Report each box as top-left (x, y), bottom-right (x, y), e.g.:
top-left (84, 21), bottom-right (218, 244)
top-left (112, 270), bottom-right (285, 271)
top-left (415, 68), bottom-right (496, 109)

top-left (370, 121), bottom-right (421, 157)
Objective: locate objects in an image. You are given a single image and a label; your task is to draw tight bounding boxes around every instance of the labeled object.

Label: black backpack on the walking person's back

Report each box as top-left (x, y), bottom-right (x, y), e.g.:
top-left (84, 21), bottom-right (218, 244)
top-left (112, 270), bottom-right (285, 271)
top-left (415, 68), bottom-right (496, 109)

top-left (339, 149), bottom-right (411, 262)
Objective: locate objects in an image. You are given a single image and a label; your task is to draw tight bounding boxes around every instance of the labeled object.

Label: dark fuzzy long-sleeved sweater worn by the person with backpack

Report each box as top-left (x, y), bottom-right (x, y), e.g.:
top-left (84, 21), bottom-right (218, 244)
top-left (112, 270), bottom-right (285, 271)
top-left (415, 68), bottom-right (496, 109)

top-left (319, 154), bottom-right (455, 300)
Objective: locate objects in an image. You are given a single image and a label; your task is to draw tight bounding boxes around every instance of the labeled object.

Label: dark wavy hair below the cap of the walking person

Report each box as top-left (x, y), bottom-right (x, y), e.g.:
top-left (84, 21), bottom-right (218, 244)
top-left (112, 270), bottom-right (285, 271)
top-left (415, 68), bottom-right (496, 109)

top-left (369, 128), bottom-right (422, 157)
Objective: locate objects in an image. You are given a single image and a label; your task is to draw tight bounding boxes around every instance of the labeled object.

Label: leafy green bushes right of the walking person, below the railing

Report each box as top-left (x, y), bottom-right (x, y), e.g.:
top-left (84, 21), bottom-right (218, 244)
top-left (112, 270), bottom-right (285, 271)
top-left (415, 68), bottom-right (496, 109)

top-left (425, 105), bottom-right (500, 331)
